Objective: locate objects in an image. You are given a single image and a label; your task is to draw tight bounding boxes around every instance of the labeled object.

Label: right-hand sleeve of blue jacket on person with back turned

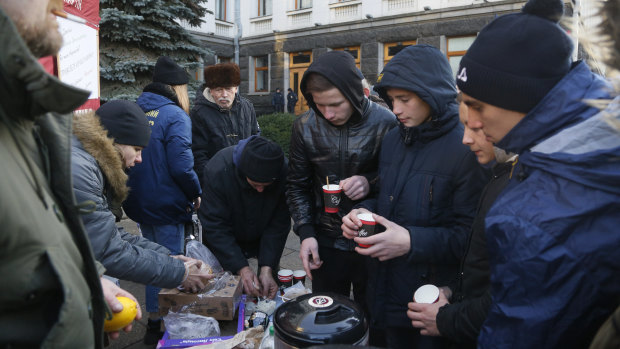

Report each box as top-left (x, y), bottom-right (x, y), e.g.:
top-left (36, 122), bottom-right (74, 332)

top-left (164, 108), bottom-right (201, 201)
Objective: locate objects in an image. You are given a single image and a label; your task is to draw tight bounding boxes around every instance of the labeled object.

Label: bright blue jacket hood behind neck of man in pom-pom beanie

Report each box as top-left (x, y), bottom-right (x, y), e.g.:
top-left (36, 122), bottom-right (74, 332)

top-left (504, 62), bottom-right (620, 193)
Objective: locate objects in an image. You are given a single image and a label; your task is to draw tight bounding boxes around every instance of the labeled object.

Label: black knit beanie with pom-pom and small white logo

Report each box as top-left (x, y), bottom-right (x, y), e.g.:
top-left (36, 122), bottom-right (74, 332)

top-left (456, 0), bottom-right (573, 113)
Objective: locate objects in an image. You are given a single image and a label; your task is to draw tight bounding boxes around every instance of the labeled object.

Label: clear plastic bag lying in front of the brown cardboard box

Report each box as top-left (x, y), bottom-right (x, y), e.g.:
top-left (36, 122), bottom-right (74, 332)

top-left (164, 311), bottom-right (220, 339)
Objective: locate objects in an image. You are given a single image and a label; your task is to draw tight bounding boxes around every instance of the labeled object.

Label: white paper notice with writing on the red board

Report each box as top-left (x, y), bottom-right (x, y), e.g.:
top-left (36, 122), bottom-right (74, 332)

top-left (57, 17), bottom-right (99, 99)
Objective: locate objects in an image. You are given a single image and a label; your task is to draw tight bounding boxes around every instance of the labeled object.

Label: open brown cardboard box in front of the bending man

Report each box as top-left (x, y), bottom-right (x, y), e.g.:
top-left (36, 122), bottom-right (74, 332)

top-left (159, 275), bottom-right (242, 320)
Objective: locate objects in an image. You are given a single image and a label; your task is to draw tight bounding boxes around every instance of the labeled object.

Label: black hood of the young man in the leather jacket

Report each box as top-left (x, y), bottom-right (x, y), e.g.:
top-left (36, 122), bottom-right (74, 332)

top-left (300, 51), bottom-right (368, 124)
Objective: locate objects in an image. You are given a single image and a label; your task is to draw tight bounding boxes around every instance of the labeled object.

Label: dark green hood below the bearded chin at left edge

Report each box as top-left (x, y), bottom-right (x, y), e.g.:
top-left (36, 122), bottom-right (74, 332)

top-left (0, 10), bottom-right (90, 120)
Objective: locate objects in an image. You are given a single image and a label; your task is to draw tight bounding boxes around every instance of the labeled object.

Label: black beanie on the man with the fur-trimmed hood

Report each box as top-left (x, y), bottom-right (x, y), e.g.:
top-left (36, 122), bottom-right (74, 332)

top-left (95, 100), bottom-right (151, 148)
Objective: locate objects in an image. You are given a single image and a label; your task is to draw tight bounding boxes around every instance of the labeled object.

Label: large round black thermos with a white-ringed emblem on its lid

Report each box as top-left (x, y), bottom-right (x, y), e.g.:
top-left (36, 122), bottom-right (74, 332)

top-left (273, 293), bottom-right (368, 349)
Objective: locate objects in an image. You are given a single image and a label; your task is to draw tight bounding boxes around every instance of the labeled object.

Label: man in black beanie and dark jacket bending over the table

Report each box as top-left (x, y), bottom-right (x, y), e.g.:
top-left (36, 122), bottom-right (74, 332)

top-left (198, 136), bottom-right (291, 298)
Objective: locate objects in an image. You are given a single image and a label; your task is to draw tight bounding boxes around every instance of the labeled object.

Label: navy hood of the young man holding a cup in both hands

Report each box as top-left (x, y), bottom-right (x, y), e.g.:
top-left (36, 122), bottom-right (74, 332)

top-left (374, 45), bottom-right (458, 144)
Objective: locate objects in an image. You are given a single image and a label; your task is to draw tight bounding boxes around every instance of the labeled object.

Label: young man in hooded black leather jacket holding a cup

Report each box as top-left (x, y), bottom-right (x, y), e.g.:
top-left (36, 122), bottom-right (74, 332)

top-left (287, 51), bottom-right (396, 304)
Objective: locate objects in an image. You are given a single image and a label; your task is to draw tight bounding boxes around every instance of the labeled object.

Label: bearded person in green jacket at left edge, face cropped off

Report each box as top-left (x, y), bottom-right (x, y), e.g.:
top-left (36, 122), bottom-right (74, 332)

top-left (0, 0), bottom-right (141, 348)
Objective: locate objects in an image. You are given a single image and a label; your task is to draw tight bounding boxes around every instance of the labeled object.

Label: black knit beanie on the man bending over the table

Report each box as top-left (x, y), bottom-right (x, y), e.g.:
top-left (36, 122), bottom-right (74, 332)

top-left (239, 136), bottom-right (284, 183)
